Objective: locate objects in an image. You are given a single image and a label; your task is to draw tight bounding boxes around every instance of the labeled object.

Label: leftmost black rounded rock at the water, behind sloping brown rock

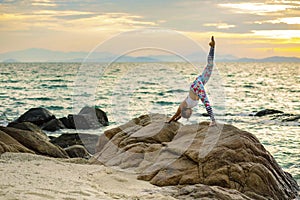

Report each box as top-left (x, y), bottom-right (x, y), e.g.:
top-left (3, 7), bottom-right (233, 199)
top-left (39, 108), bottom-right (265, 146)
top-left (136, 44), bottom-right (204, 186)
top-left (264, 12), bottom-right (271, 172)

top-left (12, 108), bottom-right (55, 126)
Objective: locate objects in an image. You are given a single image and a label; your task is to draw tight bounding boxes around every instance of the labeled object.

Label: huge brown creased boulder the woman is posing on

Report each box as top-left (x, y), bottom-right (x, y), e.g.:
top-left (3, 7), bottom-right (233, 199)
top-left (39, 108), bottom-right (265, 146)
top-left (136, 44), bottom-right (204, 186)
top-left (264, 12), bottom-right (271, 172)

top-left (92, 114), bottom-right (299, 200)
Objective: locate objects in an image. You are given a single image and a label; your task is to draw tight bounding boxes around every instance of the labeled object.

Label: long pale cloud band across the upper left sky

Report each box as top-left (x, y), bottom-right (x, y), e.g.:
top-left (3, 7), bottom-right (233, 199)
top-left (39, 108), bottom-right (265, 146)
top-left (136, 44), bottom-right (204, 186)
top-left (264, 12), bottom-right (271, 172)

top-left (0, 10), bottom-right (157, 32)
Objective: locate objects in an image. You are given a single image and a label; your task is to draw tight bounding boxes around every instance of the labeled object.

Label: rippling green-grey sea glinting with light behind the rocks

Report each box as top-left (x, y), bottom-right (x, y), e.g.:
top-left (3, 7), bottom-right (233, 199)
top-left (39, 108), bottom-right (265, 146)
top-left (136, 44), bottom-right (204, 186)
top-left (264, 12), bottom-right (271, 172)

top-left (0, 62), bottom-right (300, 184)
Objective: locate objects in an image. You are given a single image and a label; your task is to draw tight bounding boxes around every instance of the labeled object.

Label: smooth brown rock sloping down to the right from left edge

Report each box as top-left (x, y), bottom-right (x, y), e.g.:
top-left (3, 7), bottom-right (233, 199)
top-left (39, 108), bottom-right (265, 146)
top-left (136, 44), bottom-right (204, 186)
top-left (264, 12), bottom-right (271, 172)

top-left (0, 126), bottom-right (68, 158)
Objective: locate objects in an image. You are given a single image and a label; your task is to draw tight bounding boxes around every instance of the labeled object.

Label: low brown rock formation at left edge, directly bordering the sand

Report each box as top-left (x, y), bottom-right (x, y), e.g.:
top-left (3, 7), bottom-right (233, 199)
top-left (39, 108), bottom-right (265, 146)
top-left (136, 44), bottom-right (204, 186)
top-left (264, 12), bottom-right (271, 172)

top-left (0, 122), bottom-right (98, 159)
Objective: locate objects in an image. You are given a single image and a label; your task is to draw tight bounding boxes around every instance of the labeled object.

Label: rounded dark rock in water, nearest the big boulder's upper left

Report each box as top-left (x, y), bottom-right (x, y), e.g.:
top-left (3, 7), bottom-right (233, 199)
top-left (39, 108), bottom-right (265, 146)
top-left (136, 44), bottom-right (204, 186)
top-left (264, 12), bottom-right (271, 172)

top-left (78, 106), bottom-right (109, 128)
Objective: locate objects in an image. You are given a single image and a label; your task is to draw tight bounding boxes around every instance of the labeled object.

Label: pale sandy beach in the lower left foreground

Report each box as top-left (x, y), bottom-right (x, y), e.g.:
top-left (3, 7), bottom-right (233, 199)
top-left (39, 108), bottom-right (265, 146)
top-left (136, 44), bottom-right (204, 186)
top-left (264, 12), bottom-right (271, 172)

top-left (0, 153), bottom-right (173, 200)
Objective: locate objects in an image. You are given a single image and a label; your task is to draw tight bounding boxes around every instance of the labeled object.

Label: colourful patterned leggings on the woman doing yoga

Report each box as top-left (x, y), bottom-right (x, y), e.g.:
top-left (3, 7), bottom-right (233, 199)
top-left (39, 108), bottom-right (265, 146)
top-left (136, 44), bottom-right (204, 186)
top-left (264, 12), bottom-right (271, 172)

top-left (190, 47), bottom-right (215, 121)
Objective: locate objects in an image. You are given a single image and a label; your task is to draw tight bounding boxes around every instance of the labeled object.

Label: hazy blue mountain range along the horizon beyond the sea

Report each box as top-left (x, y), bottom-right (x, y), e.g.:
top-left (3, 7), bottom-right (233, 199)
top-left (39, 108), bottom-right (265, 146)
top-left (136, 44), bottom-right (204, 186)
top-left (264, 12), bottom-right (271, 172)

top-left (0, 48), bottom-right (300, 63)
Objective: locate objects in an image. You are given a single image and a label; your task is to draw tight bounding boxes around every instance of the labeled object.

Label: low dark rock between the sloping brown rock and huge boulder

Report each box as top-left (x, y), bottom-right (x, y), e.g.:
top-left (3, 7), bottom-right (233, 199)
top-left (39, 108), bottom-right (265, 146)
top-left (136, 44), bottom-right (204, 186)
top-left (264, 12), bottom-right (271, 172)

top-left (50, 133), bottom-right (98, 154)
